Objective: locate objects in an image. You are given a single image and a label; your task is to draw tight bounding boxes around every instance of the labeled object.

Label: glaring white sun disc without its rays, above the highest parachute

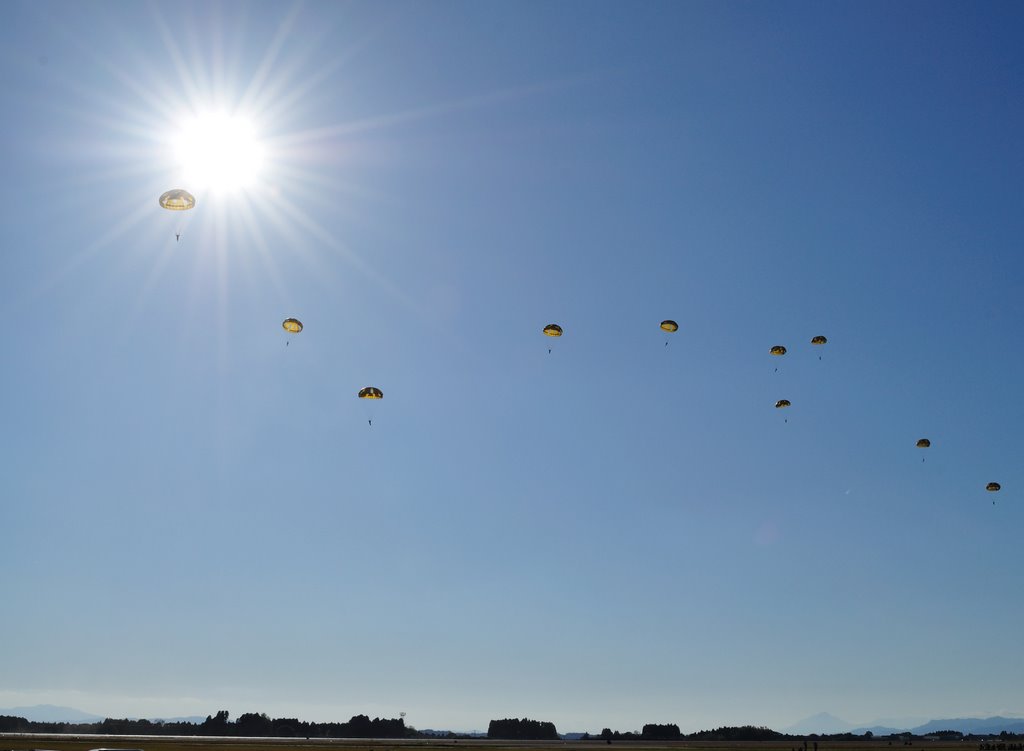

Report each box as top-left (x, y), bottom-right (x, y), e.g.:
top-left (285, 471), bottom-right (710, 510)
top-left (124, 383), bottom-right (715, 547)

top-left (174, 113), bottom-right (263, 192)
